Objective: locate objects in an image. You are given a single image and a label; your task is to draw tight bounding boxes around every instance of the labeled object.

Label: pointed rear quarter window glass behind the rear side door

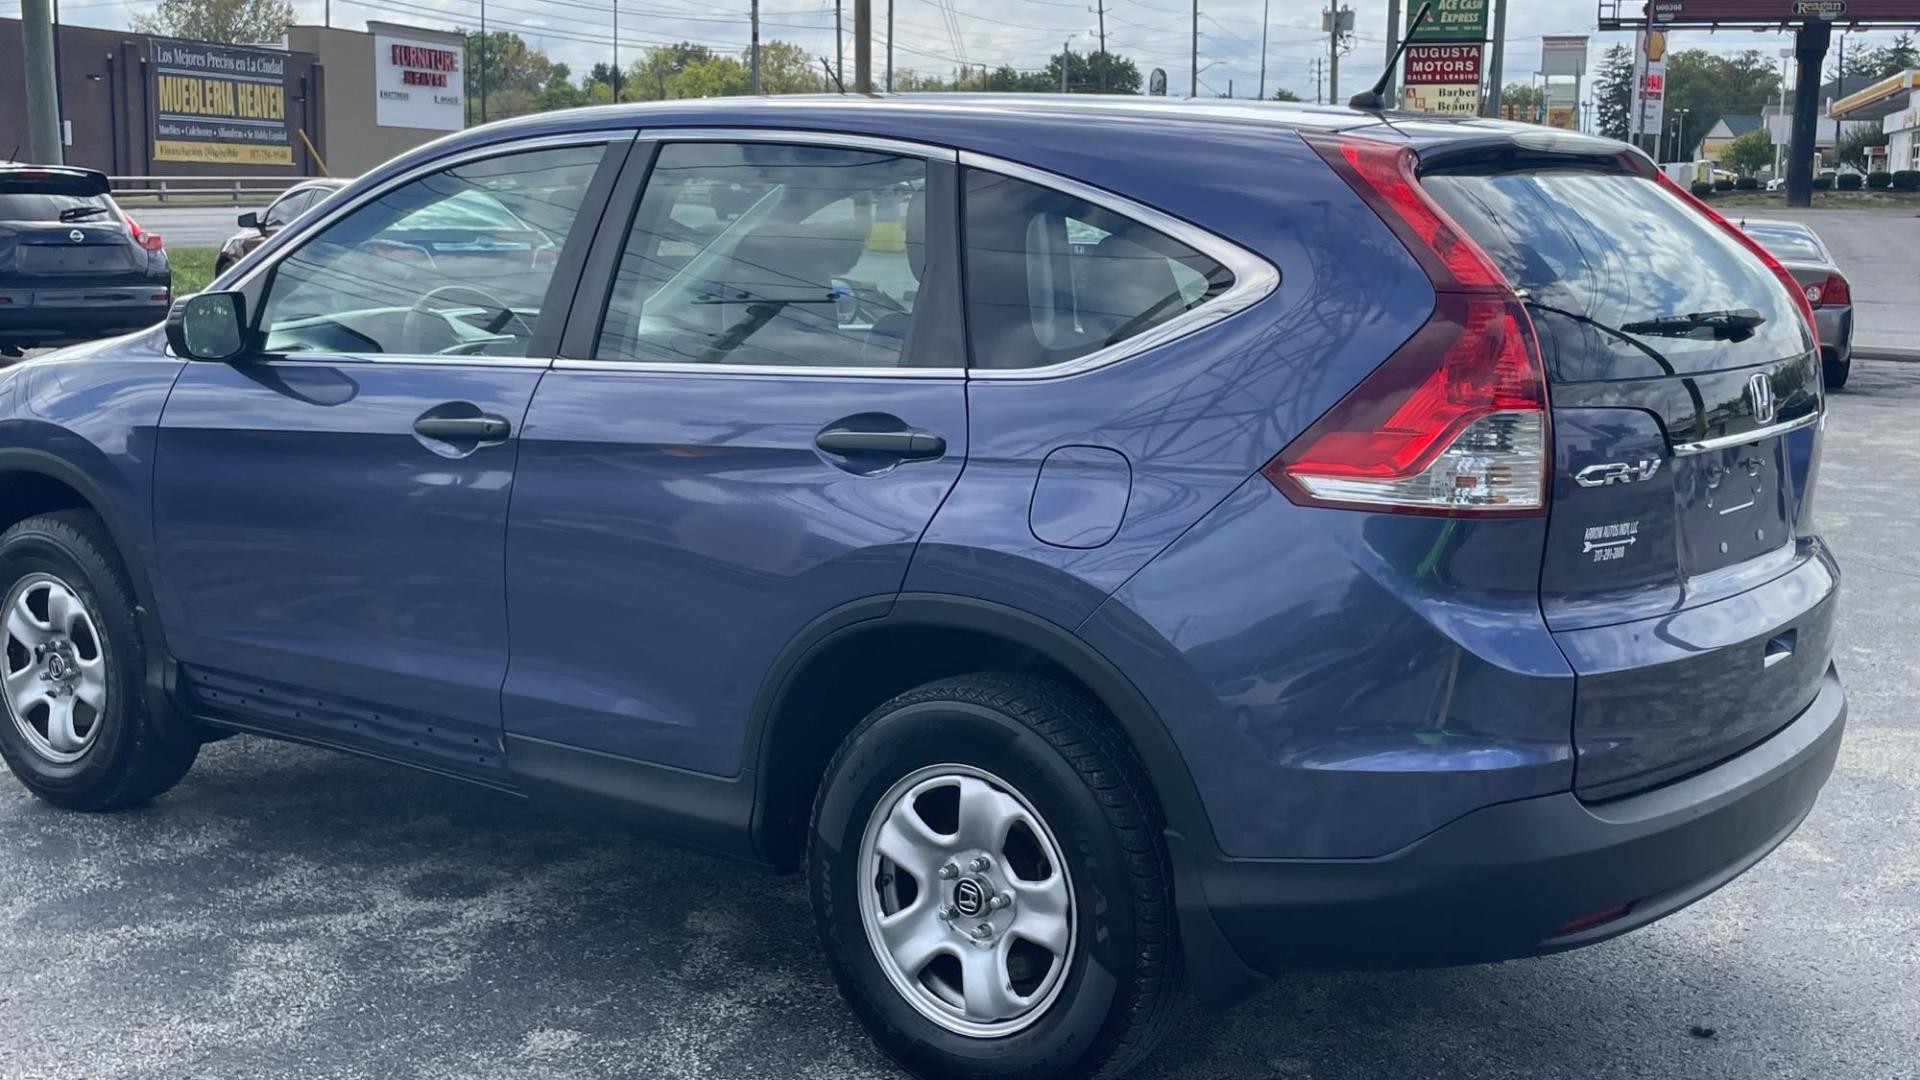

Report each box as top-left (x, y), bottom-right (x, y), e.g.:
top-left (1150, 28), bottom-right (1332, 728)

top-left (966, 169), bottom-right (1233, 369)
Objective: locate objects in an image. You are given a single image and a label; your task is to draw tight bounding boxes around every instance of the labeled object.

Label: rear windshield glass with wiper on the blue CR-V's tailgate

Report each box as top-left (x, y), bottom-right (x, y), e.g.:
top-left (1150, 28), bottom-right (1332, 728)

top-left (1423, 171), bottom-right (1807, 382)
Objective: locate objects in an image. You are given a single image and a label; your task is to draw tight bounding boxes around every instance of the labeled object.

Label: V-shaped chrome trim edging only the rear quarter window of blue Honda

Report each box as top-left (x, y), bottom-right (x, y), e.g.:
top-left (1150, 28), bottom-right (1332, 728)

top-left (960, 150), bottom-right (1281, 380)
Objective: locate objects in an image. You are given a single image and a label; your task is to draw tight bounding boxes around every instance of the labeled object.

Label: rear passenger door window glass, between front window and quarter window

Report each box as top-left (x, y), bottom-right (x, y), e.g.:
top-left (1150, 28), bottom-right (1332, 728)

top-left (593, 142), bottom-right (936, 369)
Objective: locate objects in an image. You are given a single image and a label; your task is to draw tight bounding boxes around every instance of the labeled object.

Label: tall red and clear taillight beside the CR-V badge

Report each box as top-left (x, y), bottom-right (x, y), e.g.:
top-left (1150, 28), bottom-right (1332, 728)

top-left (1261, 136), bottom-right (1551, 515)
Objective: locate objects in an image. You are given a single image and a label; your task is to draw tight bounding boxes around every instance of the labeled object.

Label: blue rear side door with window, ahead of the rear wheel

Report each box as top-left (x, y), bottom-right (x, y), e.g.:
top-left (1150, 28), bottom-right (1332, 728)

top-left (503, 136), bottom-right (966, 776)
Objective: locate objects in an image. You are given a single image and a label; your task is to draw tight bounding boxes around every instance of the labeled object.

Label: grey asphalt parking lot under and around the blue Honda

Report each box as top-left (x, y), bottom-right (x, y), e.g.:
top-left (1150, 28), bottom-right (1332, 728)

top-left (0, 363), bottom-right (1920, 1080)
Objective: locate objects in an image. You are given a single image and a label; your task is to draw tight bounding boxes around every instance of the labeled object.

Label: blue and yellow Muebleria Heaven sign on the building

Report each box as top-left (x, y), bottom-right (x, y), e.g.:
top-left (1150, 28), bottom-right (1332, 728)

top-left (146, 38), bottom-right (294, 165)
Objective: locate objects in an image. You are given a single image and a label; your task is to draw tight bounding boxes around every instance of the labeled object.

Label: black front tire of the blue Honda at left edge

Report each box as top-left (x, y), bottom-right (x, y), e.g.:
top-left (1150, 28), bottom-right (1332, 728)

top-left (0, 509), bottom-right (200, 811)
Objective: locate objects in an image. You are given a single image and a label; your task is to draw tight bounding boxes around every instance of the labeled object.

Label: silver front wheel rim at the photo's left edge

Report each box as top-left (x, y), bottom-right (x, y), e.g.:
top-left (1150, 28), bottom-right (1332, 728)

top-left (0, 573), bottom-right (108, 765)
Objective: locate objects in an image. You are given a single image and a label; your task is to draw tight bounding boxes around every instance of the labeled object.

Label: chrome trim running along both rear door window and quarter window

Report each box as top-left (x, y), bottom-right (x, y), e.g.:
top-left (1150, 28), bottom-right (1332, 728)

top-left (553, 127), bottom-right (1281, 380)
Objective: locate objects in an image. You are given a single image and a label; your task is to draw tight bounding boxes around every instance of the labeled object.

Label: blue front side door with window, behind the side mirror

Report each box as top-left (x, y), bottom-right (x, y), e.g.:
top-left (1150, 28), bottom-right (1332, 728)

top-left (154, 140), bottom-right (624, 776)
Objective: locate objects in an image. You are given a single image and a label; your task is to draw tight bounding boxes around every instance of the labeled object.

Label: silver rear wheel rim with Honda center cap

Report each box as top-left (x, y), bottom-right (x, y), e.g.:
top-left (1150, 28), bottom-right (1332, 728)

top-left (858, 765), bottom-right (1075, 1038)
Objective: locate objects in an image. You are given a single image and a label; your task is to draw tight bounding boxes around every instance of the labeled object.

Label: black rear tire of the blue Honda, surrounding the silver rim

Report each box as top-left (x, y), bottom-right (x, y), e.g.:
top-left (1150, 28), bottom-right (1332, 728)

top-left (806, 675), bottom-right (1185, 1080)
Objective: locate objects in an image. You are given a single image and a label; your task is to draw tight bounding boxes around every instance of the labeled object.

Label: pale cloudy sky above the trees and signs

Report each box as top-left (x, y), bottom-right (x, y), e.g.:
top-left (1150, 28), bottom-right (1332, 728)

top-left (0, 0), bottom-right (1891, 100)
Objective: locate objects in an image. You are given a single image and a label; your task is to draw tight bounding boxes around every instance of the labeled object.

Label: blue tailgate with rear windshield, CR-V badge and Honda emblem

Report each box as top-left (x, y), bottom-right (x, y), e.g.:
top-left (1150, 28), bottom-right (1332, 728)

top-left (1423, 163), bottom-right (1832, 798)
